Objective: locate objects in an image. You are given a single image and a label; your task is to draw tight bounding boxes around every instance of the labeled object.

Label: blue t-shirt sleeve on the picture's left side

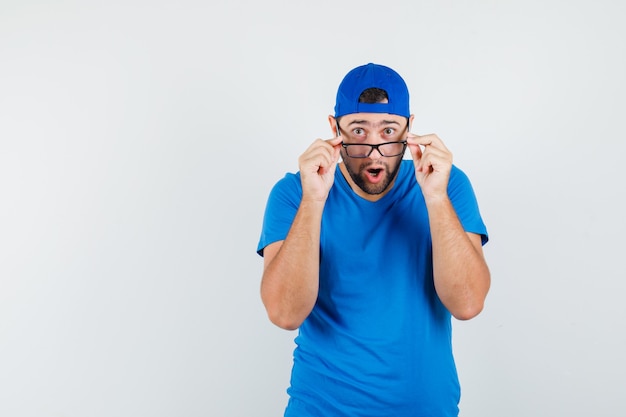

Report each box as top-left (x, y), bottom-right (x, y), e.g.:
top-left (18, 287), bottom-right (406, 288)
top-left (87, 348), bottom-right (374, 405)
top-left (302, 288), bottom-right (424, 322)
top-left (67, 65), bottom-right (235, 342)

top-left (257, 174), bottom-right (302, 256)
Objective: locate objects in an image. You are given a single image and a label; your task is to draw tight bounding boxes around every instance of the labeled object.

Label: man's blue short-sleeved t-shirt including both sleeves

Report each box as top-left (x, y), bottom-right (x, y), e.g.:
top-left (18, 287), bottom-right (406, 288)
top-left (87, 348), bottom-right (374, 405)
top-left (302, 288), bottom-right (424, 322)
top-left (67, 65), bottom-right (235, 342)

top-left (257, 160), bottom-right (487, 417)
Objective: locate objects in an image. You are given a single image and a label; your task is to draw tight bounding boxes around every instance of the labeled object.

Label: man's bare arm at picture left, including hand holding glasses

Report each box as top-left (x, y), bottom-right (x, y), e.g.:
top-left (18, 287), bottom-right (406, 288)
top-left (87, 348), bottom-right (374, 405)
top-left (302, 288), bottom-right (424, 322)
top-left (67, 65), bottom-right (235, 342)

top-left (261, 138), bottom-right (341, 330)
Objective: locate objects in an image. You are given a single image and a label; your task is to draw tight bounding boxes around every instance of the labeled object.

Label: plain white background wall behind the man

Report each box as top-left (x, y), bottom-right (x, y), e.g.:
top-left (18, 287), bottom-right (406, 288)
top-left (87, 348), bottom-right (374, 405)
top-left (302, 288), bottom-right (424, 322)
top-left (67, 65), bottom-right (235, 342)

top-left (0, 0), bottom-right (626, 417)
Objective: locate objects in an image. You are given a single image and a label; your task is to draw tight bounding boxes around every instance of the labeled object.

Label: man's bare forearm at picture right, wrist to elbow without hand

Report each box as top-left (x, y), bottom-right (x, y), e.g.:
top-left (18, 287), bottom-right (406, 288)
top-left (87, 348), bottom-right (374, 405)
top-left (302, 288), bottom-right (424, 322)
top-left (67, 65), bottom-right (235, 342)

top-left (427, 198), bottom-right (491, 320)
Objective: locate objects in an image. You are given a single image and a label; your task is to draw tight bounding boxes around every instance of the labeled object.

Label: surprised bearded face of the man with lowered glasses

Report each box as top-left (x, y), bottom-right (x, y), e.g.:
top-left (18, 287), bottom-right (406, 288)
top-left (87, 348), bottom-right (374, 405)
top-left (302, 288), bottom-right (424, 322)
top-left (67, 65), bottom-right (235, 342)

top-left (338, 113), bottom-right (409, 195)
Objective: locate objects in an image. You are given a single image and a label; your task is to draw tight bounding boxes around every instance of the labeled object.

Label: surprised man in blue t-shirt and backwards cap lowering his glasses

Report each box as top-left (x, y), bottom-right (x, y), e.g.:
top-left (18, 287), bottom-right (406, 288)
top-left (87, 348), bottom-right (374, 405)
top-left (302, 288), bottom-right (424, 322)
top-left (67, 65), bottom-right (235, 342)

top-left (258, 63), bottom-right (490, 417)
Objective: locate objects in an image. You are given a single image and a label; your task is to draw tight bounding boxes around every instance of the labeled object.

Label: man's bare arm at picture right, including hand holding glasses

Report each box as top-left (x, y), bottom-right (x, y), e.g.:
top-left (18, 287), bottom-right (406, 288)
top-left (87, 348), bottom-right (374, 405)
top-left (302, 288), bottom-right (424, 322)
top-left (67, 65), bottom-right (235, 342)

top-left (409, 135), bottom-right (491, 320)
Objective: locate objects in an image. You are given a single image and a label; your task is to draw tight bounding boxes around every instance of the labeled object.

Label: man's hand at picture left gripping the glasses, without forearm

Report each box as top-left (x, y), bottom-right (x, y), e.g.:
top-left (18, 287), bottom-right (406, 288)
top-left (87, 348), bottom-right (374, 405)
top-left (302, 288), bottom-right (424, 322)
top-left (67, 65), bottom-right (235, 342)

top-left (298, 136), bottom-right (342, 202)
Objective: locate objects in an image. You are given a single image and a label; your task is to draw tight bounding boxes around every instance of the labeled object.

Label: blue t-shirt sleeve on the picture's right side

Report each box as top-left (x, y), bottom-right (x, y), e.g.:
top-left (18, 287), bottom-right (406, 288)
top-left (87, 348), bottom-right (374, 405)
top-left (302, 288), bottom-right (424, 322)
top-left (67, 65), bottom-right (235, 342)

top-left (448, 165), bottom-right (489, 245)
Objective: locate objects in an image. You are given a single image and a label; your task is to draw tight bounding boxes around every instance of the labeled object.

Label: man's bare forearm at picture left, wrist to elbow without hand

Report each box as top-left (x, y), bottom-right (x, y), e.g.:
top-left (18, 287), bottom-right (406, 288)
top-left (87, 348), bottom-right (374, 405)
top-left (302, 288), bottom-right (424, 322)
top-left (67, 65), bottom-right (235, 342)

top-left (261, 202), bottom-right (324, 330)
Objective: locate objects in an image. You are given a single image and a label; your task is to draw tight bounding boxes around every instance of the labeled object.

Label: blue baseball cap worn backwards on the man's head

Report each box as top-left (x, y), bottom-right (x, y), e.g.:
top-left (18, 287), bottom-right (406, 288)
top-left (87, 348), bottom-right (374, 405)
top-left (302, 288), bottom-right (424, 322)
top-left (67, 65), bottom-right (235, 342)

top-left (335, 63), bottom-right (411, 117)
